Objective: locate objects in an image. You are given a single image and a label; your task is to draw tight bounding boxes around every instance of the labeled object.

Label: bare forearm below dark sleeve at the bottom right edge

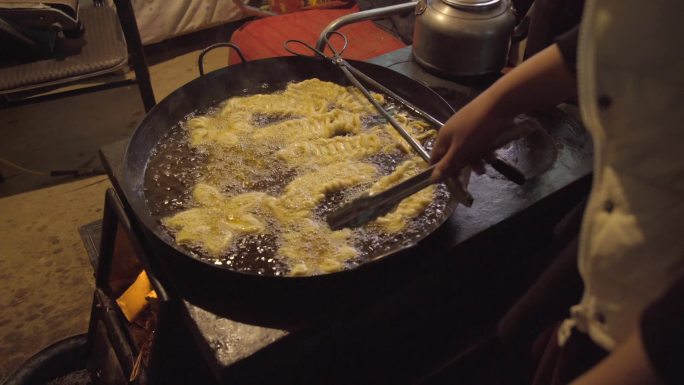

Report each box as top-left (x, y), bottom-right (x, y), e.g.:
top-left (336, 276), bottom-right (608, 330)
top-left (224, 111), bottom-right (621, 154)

top-left (570, 330), bottom-right (659, 385)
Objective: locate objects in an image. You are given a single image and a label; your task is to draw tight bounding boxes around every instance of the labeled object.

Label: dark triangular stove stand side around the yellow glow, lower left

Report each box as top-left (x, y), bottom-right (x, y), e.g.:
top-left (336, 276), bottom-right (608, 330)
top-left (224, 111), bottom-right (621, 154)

top-left (86, 189), bottom-right (216, 385)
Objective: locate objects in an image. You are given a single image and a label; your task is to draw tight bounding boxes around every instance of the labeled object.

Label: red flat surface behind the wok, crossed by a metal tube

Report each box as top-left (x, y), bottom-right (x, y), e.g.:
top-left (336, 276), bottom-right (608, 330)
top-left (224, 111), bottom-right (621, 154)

top-left (229, 6), bottom-right (406, 64)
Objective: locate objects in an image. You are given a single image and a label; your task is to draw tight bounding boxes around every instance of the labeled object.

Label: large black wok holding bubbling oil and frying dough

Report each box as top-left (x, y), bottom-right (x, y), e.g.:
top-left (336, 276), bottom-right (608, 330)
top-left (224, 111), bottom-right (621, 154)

top-left (123, 57), bottom-right (454, 322)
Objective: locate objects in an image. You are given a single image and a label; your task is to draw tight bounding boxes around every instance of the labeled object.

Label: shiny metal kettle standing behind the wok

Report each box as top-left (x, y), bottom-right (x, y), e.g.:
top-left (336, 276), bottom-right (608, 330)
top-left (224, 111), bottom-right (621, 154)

top-left (413, 0), bottom-right (515, 77)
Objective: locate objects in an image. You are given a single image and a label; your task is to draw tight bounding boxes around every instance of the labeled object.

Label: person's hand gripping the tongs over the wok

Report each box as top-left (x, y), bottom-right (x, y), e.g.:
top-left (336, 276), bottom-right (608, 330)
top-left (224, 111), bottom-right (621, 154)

top-left (431, 95), bottom-right (503, 181)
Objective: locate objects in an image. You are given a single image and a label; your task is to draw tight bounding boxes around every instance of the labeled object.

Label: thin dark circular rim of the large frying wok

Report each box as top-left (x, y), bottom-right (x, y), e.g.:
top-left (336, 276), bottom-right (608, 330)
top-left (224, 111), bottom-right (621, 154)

top-left (121, 56), bottom-right (459, 282)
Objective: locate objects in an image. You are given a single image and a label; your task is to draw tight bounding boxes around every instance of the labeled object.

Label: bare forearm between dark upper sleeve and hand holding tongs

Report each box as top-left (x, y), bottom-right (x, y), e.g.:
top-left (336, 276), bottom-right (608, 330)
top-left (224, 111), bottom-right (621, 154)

top-left (478, 44), bottom-right (577, 119)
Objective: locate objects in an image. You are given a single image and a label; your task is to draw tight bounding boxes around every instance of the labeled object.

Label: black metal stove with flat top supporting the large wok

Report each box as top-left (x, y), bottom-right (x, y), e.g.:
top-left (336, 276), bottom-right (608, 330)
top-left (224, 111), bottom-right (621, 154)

top-left (89, 47), bottom-right (592, 384)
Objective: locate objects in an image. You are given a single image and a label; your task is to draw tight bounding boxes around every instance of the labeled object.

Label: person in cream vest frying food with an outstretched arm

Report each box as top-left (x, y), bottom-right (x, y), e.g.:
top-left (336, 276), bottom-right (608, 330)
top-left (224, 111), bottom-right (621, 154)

top-left (432, 0), bottom-right (684, 385)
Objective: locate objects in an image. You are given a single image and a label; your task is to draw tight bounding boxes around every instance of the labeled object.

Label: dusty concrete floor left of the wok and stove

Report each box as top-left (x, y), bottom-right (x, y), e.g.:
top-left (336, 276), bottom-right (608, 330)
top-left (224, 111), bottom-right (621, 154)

top-left (0, 41), bottom-right (227, 382)
